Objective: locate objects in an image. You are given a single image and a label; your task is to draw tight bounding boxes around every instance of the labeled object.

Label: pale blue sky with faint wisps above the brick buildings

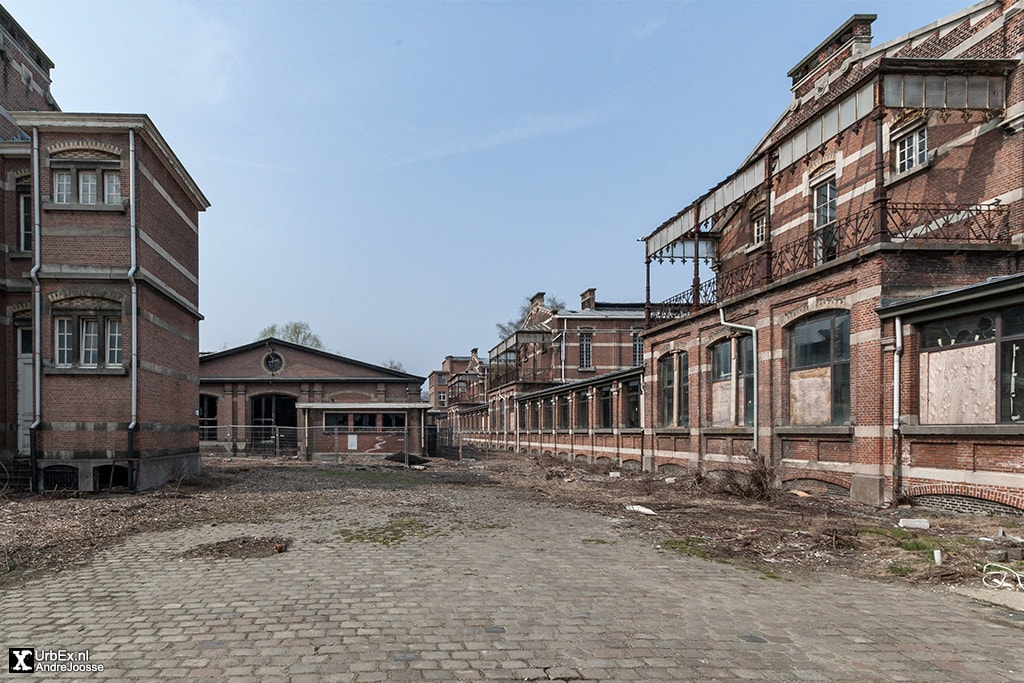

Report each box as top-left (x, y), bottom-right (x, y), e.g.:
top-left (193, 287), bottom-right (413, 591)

top-left (2, 0), bottom-right (972, 376)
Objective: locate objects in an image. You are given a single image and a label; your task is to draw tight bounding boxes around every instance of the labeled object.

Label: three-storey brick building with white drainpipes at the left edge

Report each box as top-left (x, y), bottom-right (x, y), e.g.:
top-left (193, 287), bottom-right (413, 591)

top-left (0, 2), bottom-right (209, 490)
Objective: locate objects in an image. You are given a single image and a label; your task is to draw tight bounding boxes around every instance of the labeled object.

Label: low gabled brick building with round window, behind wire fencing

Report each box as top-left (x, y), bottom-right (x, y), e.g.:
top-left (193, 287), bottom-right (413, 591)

top-left (199, 337), bottom-right (430, 459)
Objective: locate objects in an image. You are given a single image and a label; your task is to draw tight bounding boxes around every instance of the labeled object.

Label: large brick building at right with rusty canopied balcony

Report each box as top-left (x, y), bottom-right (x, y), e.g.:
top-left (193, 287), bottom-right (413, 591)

top-left (643, 0), bottom-right (1024, 509)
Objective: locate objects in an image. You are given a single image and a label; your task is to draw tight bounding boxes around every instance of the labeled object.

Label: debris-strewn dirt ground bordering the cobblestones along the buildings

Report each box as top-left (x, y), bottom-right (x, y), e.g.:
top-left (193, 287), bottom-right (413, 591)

top-left (0, 454), bottom-right (1024, 589)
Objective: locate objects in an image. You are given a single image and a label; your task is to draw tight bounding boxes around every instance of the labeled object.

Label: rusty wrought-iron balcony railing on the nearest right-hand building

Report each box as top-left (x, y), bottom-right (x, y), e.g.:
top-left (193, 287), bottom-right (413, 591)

top-left (648, 203), bottom-right (1010, 326)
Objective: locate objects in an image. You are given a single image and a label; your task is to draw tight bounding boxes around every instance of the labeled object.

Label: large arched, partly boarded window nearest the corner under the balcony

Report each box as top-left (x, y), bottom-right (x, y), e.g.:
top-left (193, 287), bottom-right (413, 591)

top-left (790, 311), bottom-right (850, 425)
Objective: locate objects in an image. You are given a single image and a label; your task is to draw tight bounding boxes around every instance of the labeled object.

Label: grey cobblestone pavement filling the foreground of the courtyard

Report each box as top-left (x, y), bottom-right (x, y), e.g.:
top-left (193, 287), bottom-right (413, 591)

top-left (0, 486), bottom-right (1024, 683)
